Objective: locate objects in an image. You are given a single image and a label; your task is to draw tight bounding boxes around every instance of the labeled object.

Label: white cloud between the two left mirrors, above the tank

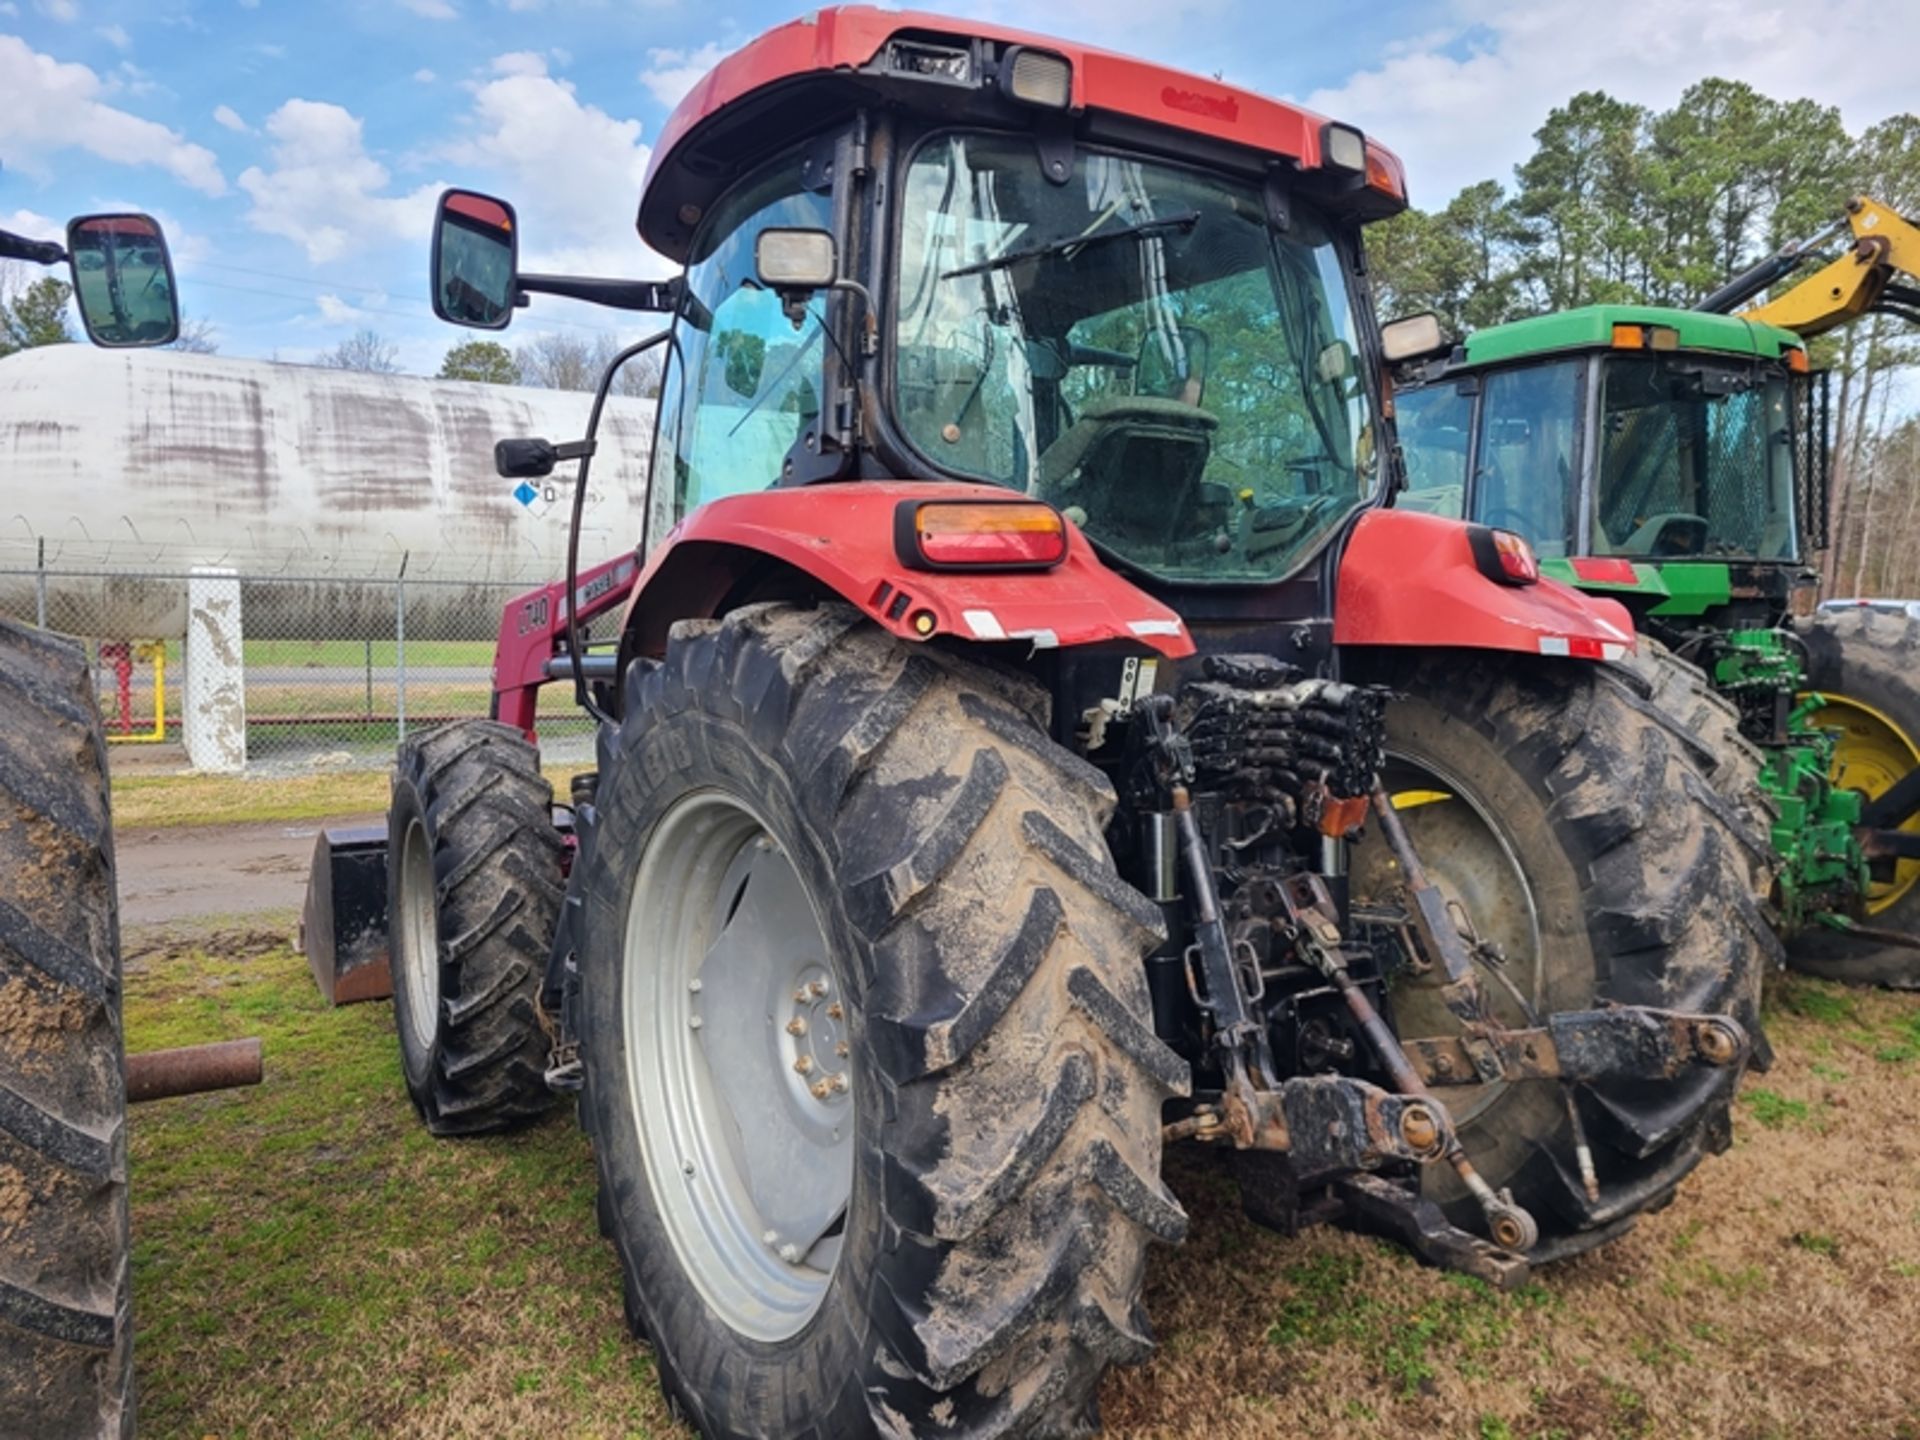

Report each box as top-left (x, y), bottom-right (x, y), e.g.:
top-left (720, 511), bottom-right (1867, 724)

top-left (240, 100), bottom-right (442, 265)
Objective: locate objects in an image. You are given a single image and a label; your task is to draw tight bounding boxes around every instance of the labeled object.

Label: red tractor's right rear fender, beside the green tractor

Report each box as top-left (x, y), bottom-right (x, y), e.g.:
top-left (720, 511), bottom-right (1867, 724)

top-left (1332, 511), bottom-right (1634, 660)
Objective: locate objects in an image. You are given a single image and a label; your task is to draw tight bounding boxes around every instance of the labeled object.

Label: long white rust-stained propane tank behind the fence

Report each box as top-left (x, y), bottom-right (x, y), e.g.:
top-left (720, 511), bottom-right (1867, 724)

top-left (0, 346), bottom-right (664, 639)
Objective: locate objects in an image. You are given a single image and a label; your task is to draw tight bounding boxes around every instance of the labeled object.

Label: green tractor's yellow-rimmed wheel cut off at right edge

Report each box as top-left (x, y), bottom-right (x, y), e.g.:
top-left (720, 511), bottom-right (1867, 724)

top-left (1788, 607), bottom-right (1920, 989)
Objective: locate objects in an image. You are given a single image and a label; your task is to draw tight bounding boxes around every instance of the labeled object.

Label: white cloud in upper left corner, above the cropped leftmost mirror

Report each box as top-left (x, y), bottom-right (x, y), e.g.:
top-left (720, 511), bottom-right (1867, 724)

top-left (0, 35), bottom-right (227, 196)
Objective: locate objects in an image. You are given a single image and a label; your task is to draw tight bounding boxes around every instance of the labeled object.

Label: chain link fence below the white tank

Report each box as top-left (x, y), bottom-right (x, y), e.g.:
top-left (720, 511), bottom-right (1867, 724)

top-left (0, 566), bottom-right (599, 774)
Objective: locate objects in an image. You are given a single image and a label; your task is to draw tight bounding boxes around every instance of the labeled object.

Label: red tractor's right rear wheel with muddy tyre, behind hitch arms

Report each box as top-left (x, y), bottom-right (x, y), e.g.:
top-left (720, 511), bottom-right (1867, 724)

top-left (1354, 655), bottom-right (1780, 1260)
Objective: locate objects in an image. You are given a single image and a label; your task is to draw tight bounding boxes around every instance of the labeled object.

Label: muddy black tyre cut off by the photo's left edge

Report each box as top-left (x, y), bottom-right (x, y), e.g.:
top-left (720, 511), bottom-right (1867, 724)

top-left (0, 622), bottom-right (132, 1440)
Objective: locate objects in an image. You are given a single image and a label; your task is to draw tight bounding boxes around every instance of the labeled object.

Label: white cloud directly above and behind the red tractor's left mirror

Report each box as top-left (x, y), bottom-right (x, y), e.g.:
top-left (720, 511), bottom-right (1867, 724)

top-left (440, 52), bottom-right (657, 275)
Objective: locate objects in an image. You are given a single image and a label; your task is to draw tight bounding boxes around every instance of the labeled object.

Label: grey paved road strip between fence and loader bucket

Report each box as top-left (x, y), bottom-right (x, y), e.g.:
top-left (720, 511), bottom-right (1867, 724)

top-left (113, 816), bottom-right (382, 925)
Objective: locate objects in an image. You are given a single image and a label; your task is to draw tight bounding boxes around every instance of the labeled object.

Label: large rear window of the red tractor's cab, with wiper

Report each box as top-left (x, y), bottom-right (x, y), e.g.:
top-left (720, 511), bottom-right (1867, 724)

top-left (895, 134), bottom-right (1375, 584)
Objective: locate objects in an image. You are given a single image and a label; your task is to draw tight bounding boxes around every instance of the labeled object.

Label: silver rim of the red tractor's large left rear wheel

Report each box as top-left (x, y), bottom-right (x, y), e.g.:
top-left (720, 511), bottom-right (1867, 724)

top-left (620, 789), bottom-right (854, 1340)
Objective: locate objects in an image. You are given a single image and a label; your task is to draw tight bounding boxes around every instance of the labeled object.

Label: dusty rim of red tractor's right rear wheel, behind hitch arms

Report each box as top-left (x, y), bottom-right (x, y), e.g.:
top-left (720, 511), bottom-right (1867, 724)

top-left (1380, 753), bottom-right (1546, 1125)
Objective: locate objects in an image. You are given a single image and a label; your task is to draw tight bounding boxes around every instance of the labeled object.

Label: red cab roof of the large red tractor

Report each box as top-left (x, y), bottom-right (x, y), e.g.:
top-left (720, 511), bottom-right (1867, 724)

top-left (639, 6), bottom-right (1407, 261)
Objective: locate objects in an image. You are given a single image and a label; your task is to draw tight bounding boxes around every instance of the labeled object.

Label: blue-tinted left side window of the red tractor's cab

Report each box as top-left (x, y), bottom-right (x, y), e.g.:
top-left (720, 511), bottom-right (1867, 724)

top-left (649, 154), bottom-right (833, 541)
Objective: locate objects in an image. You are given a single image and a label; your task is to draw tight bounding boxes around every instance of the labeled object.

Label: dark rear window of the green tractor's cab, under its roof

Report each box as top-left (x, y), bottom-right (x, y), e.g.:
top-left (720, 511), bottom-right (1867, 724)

top-left (1594, 355), bottom-right (1795, 561)
